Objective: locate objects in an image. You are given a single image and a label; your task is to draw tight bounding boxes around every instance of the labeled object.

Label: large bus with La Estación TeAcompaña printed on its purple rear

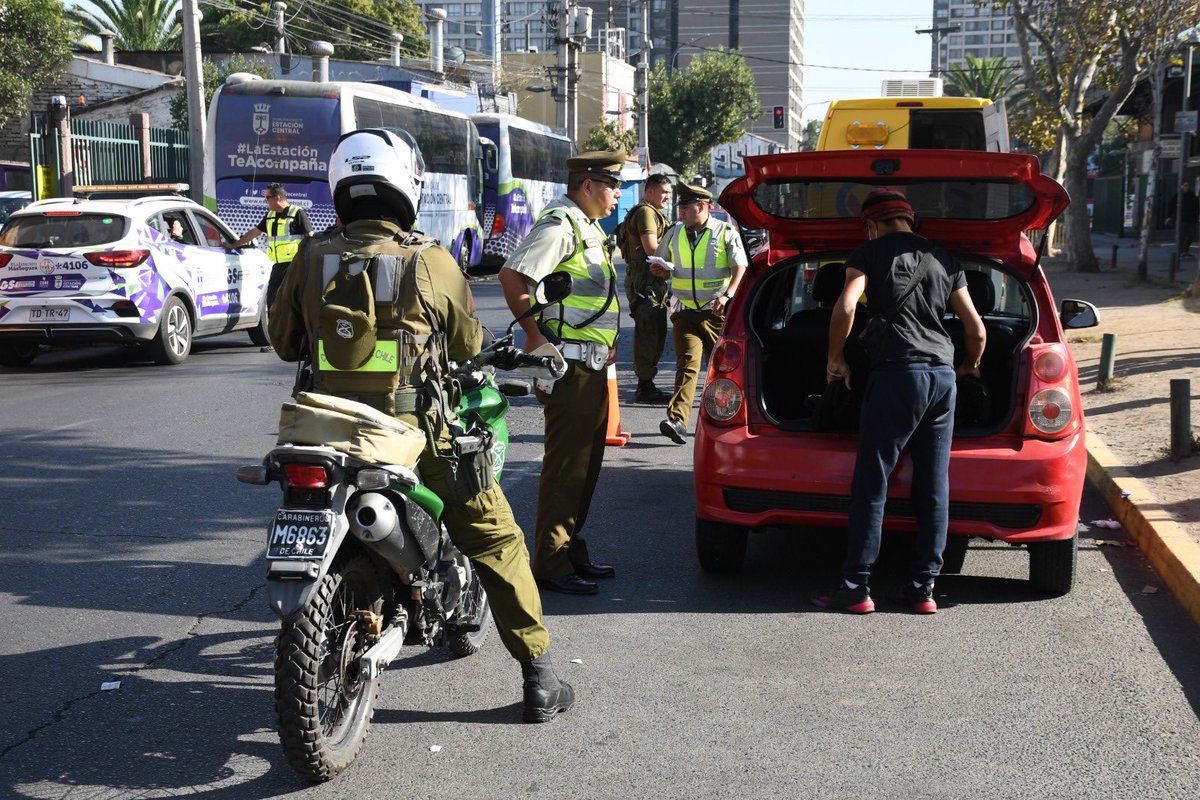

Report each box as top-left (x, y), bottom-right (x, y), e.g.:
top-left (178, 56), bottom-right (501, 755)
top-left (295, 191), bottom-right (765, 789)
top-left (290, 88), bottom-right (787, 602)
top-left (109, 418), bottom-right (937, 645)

top-left (204, 74), bottom-right (484, 270)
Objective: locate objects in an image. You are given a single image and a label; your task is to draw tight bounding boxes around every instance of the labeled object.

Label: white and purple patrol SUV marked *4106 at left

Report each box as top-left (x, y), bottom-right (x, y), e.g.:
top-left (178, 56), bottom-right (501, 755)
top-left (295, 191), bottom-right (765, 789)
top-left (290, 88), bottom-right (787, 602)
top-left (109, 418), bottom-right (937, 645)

top-left (0, 196), bottom-right (271, 367)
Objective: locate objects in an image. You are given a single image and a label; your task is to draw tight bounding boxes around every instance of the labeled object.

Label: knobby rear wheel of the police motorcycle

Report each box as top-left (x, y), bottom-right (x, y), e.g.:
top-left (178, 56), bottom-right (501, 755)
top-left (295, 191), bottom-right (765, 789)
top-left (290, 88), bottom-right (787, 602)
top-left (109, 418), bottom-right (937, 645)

top-left (275, 555), bottom-right (384, 783)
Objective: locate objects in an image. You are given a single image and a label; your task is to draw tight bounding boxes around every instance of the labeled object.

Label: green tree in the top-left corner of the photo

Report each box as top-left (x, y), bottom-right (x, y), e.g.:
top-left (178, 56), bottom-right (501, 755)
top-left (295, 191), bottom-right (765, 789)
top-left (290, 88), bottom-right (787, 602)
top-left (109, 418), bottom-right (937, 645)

top-left (0, 0), bottom-right (79, 125)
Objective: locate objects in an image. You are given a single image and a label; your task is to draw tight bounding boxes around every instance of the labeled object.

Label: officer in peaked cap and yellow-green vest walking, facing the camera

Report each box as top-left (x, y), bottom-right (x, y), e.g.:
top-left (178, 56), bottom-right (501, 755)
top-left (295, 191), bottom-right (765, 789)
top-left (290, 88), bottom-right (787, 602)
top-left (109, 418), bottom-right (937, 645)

top-left (652, 184), bottom-right (748, 445)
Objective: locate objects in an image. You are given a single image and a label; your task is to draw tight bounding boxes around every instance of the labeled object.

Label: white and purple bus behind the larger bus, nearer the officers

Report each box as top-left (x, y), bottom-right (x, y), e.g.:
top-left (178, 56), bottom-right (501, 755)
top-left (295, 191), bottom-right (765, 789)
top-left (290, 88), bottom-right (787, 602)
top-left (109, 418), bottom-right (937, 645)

top-left (470, 114), bottom-right (575, 263)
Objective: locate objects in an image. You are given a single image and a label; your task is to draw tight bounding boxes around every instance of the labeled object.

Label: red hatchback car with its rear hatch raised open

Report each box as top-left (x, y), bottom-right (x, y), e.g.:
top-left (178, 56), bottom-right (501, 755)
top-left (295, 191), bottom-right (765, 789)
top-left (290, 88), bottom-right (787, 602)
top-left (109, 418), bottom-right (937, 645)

top-left (695, 150), bottom-right (1099, 595)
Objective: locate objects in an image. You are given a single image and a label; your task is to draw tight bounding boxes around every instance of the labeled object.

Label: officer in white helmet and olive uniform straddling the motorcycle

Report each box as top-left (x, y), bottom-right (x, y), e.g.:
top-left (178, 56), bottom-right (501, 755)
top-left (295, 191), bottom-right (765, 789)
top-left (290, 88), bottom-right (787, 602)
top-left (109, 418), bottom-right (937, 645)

top-left (269, 128), bottom-right (575, 722)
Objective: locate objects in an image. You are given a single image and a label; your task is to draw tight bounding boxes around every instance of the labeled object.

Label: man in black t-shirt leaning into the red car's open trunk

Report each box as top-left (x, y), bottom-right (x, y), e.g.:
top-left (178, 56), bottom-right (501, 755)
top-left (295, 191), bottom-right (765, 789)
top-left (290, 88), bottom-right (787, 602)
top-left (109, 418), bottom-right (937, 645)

top-left (814, 188), bottom-right (986, 614)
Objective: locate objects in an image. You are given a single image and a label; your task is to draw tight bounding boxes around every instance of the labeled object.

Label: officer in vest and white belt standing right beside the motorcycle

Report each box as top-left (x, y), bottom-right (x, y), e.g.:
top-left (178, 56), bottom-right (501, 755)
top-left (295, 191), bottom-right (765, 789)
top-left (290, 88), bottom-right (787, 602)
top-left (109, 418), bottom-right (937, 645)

top-left (499, 151), bottom-right (625, 595)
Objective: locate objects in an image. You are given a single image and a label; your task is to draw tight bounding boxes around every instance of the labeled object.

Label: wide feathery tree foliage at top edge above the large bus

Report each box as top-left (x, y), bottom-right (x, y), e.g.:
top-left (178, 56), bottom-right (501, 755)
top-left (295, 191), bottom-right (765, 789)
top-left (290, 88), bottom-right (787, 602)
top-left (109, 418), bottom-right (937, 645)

top-left (200, 0), bottom-right (430, 61)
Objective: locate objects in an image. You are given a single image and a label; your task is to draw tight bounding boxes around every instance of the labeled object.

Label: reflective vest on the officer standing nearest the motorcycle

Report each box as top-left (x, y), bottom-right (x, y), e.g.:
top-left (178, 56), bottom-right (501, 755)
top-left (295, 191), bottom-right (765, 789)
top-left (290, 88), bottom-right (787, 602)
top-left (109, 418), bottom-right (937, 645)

top-left (539, 205), bottom-right (620, 348)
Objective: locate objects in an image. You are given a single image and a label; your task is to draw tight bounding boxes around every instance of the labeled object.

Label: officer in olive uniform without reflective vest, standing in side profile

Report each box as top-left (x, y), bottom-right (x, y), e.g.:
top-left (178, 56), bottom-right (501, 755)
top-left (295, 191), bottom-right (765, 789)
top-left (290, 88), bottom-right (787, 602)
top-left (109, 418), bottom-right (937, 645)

top-left (618, 173), bottom-right (671, 403)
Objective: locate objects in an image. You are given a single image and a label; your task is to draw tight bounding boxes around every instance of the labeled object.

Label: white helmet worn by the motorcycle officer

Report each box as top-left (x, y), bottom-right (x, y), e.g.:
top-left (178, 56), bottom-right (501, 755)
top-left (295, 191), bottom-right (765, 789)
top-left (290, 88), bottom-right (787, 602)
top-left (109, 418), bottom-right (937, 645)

top-left (329, 128), bottom-right (425, 230)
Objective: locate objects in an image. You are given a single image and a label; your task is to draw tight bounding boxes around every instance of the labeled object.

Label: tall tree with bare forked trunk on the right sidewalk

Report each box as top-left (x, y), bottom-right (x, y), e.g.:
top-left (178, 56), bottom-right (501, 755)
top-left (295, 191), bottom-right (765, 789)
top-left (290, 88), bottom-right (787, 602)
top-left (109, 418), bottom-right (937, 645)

top-left (1008, 0), bottom-right (1200, 272)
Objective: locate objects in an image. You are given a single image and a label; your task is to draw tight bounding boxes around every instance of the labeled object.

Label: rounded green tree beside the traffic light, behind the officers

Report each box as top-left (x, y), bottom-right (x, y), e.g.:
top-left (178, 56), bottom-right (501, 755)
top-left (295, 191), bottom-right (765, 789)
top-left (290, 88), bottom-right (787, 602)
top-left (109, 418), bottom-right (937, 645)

top-left (649, 50), bottom-right (762, 175)
